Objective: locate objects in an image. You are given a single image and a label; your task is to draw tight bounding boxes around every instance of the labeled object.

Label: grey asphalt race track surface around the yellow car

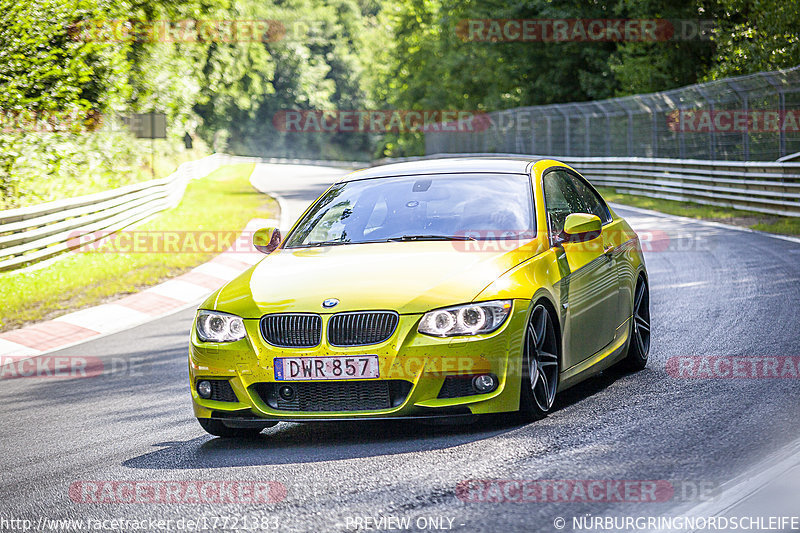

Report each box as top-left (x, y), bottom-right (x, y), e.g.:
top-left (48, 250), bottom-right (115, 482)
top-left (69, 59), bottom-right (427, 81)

top-left (0, 165), bottom-right (800, 532)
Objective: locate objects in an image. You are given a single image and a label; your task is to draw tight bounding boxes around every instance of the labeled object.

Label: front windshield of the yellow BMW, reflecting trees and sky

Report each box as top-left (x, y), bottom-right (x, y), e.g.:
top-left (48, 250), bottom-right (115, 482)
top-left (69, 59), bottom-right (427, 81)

top-left (285, 174), bottom-right (534, 248)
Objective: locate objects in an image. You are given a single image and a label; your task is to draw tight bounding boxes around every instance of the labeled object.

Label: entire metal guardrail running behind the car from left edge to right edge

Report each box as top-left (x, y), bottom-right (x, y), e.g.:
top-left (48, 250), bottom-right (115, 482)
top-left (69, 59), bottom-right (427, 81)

top-left (0, 148), bottom-right (800, 271)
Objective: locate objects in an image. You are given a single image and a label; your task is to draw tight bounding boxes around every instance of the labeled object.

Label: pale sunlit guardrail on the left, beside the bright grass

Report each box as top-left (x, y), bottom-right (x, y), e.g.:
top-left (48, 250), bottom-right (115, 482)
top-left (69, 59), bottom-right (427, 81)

top-left (0, 154), bottom-right (230, 271)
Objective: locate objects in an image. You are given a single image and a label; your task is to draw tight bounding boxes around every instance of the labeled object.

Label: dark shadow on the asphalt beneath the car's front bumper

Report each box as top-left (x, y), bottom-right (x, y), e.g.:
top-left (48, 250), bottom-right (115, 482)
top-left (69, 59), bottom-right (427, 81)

top-left (122, 417), bottom-right (519, 469)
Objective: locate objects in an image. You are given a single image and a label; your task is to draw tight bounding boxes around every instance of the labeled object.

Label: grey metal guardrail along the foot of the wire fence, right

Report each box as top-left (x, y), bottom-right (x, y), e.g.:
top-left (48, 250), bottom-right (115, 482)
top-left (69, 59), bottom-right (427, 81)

top-left (381, 152), bottom-right (800, 217)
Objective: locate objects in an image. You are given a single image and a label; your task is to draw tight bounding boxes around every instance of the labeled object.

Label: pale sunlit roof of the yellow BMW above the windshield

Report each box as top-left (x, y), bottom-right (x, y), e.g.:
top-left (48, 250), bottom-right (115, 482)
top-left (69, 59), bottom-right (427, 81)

top-left (339, 157), bottom-right (536, 182)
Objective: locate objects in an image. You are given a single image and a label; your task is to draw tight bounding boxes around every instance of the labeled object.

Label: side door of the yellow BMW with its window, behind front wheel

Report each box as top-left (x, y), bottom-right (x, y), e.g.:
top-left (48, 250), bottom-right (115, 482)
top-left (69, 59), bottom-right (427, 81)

top-left (542, 167), bottom-right (619, 369)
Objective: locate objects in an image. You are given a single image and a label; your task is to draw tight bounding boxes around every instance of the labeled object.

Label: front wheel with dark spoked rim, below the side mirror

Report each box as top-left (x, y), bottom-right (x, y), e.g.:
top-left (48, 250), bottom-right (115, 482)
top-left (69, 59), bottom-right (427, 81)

top-left (519, 303), bottom-right (561, 420)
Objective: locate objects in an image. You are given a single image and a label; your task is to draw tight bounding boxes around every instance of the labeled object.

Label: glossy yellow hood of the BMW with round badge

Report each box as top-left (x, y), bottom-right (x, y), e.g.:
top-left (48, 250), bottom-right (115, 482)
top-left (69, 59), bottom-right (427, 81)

top-left (209, 241), bottom-right (535, 318)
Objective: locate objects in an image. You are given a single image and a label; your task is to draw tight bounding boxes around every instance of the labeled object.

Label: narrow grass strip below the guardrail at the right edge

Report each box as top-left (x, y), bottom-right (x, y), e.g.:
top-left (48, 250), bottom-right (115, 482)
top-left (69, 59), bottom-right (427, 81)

top-left (598, 187), bottom-right (800, 235)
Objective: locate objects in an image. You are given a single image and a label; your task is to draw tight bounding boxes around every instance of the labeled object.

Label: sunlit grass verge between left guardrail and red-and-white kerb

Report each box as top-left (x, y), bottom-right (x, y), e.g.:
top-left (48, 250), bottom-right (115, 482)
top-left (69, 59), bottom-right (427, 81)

top-left (0, 163), bottom-right (278, 331)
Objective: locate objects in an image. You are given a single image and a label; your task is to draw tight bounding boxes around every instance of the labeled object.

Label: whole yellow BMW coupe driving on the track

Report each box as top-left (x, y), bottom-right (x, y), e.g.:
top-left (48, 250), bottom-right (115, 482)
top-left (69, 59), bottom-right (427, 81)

top-left (189, 158), bottom-right (650, 437)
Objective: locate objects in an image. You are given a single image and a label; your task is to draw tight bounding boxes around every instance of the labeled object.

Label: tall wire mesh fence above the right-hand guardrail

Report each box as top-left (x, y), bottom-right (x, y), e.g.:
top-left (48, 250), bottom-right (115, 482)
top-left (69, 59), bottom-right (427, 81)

top-left (425, 67), bottom-right (800, 161)
